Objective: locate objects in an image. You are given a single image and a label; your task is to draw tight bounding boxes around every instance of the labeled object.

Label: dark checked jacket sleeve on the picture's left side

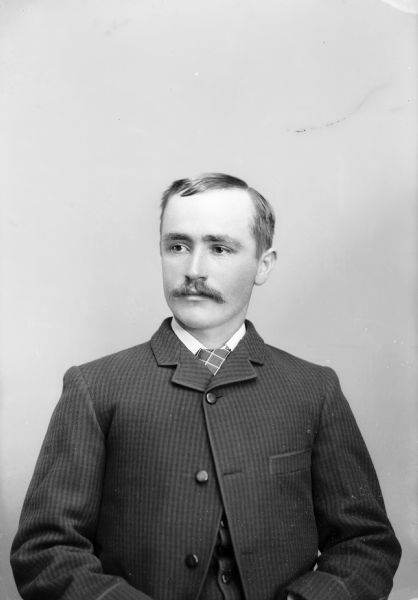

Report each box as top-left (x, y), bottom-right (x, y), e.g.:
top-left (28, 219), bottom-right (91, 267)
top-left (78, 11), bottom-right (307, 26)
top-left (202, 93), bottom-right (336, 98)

top-left (11, 367), bottom-right (150, 600)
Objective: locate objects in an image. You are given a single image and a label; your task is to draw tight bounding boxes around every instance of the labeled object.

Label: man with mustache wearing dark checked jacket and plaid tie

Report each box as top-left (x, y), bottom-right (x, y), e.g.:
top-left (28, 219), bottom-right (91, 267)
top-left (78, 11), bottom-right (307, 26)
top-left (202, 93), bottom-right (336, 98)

top-left (12, 173), bottom-right (400, 600)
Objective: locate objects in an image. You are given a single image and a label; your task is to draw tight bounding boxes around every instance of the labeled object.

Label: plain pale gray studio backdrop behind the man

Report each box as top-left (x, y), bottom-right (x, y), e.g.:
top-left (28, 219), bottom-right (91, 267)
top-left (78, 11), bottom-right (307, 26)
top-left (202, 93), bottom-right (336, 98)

top-left (0, 0), bottom-right (418, 600)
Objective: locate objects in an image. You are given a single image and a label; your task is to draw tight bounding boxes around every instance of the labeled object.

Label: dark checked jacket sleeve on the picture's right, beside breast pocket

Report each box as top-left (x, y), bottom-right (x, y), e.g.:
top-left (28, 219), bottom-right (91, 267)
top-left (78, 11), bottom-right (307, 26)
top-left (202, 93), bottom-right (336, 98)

top-left (287, 367), bottom-right (401, 600)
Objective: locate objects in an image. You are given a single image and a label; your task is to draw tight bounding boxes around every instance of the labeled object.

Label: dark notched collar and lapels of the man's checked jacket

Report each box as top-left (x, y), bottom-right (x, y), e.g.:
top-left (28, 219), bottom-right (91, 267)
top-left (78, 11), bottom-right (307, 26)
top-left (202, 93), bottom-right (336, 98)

top-left (151, 318), bottom-right (265, 392)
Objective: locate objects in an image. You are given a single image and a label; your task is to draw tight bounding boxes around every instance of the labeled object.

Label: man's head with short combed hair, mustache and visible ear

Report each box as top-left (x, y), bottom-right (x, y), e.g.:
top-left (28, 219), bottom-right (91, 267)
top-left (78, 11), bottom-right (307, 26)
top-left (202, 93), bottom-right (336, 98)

top-left (160, 173), bottom-right (275, 342)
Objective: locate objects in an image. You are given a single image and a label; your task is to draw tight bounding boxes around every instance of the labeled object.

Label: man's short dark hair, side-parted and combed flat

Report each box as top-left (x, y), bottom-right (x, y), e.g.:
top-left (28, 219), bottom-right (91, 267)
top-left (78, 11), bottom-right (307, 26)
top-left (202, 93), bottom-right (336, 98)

top-left (160, 173), bottom-right (275, 257)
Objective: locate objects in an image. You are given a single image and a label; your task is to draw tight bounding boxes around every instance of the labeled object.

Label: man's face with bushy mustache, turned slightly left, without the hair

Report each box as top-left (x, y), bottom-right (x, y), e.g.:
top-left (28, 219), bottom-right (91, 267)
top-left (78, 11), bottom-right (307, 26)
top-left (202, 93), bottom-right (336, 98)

top-left (161, 189), bottom-right (274, 334)
